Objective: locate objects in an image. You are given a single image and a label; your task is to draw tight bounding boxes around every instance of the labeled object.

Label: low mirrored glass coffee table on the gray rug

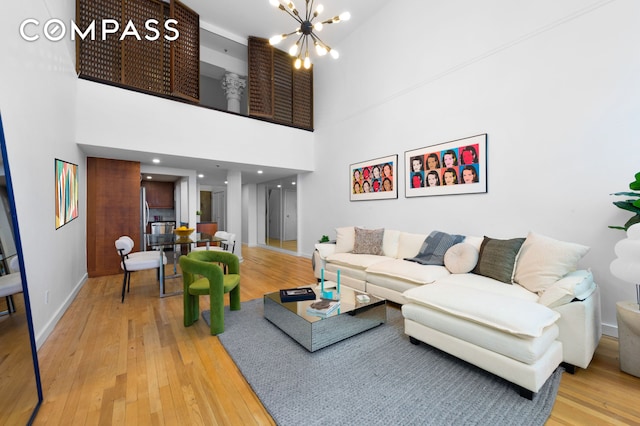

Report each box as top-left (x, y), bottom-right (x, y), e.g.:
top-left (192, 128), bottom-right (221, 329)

top-left (264, 284), bottom-right (387, 352)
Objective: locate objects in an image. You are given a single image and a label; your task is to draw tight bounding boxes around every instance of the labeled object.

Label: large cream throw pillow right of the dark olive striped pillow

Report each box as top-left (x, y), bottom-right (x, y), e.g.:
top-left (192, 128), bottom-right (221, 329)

top-left (515, 232), bottom-right (589, 295)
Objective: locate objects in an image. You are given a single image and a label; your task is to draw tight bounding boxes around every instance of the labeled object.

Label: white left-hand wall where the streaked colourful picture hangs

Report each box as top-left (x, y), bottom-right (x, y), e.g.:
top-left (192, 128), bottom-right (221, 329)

top-left (0, 0), bottom-right (87, 346)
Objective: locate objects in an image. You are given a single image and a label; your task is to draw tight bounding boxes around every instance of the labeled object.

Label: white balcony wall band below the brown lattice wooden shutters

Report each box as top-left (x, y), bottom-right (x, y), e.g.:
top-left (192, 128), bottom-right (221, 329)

top-left (77, 80), bottom-right (314, 171)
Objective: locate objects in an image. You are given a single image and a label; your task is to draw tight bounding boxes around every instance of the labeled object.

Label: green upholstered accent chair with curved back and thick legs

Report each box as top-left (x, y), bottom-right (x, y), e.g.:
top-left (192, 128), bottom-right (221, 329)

top-left (180, 250), bottom-right (240, 335)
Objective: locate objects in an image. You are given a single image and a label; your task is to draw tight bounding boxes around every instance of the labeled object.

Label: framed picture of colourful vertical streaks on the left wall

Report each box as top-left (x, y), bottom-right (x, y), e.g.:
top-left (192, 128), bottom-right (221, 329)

top-left (54, 158), bottom-right (78, 229)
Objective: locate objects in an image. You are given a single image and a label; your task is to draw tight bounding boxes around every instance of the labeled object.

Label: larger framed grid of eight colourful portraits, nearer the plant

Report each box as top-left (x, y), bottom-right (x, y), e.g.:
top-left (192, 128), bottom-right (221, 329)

top-left (404, 133), bottom-right (487, 197)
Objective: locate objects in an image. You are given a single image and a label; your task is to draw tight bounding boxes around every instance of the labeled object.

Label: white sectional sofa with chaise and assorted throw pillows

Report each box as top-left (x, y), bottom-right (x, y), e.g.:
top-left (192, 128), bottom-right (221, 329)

top-left (313, 227), bottom-right (602, 398)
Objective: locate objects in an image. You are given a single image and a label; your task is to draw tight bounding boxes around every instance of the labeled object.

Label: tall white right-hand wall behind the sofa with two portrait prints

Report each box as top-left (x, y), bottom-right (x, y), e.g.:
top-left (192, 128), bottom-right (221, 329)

top-left (299, 0), bottom-right (640, 334)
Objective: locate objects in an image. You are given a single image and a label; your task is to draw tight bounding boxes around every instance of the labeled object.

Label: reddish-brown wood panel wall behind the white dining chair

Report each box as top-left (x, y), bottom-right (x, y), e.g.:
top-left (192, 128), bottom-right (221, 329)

top-left (87, 157), bottom-right (140, 277)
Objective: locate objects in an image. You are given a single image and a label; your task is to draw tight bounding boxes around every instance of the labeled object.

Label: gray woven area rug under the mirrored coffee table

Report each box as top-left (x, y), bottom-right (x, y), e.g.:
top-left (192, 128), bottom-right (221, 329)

top-left (202, 299), bottom-right (563, 426)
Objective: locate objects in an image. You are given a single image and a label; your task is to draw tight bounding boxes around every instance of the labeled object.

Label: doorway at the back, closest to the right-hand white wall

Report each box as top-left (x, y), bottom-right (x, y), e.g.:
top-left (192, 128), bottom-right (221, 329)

top-left (265, 176), bottom-right (298, 252)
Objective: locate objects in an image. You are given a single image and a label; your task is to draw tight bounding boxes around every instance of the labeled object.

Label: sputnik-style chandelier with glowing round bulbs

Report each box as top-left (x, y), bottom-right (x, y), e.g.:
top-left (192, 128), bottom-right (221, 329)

top-left (269, 0), bottom-right (351, 69)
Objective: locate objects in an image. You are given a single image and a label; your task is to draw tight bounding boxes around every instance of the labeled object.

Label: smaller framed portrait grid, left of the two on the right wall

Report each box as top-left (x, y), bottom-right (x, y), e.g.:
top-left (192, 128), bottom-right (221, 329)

top-left (349, 154), bottom-right (398, 201)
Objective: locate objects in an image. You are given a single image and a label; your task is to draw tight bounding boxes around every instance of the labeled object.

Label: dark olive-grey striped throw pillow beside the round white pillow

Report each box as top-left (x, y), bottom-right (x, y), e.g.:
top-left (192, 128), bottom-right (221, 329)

top-left (471, 236), bottom-right (525, 284)
